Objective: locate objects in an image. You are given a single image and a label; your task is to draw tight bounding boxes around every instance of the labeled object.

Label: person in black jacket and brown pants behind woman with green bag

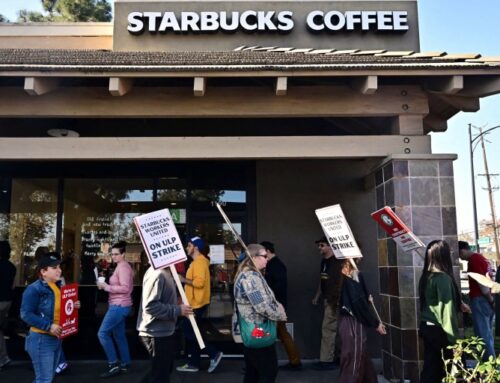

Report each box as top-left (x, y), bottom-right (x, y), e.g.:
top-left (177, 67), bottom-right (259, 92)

top-left (260, 241), bottom-right (302, 371)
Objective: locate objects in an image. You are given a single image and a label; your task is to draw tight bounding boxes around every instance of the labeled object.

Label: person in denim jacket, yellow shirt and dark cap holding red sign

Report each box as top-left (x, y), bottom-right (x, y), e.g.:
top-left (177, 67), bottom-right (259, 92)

top-left (21, 252), bottom-right (80, 383)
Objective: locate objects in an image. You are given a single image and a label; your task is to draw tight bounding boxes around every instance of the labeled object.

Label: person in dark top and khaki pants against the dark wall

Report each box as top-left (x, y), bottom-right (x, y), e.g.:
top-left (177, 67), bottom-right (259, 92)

top-left (312, 237), bottom-right (342, 370)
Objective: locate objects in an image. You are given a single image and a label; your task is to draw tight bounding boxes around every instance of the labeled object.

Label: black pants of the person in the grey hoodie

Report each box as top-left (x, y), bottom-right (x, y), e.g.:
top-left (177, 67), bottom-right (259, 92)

top-left (141, 335), bottom-right (175, 383)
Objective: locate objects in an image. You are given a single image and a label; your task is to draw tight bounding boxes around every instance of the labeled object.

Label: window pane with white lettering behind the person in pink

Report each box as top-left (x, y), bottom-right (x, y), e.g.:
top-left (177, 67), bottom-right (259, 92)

top-left (63, 179), bottom-right (154, 285)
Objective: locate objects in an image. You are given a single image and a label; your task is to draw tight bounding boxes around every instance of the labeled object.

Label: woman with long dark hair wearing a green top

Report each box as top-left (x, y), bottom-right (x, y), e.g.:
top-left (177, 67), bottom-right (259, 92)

top-left (418, 240), bottom-right (462, 383)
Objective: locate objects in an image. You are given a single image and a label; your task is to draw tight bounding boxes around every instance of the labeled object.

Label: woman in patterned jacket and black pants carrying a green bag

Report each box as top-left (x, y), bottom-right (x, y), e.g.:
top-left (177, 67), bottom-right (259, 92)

top-left (234, 244), bottom-right (286, 383)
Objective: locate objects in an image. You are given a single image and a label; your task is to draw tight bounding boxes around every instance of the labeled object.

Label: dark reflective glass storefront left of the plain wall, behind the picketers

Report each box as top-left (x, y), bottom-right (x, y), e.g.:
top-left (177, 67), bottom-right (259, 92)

top-left (0, 163), bottom-right (252, 358)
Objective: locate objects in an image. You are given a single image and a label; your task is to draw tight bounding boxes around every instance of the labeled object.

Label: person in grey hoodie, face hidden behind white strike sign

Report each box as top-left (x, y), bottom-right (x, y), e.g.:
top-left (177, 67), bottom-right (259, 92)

top-left (137, 260), bottom-right (193, 383)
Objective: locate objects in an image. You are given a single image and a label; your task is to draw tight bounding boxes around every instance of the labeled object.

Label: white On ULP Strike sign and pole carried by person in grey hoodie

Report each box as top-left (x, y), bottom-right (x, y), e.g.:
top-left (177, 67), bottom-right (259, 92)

top-left (134, 209), bottom-right (205, 349)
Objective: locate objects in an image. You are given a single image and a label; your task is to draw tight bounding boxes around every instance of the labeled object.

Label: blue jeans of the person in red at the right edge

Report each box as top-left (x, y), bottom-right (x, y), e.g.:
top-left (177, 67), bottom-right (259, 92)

top-left (471, 297), bottom-right (495, 360)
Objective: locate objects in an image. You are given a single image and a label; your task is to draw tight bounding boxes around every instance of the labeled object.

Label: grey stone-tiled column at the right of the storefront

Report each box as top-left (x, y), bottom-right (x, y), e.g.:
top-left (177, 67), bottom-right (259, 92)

top-left (375, 155), bottom-right (458, 382)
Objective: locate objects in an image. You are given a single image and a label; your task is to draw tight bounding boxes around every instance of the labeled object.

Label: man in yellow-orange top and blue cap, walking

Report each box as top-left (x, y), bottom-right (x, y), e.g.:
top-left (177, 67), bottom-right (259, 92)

top-left (177, 237), bottom-right (222, 373)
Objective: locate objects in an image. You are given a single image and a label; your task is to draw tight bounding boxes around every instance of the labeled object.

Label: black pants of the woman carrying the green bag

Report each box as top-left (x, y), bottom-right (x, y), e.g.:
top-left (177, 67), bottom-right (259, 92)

top-left (243, 345), bottom-right (278, 383)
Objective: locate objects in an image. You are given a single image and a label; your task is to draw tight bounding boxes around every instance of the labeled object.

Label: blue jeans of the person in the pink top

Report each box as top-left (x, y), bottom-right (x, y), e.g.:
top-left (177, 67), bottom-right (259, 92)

top-left (97, 305), bottom-right (131, 364)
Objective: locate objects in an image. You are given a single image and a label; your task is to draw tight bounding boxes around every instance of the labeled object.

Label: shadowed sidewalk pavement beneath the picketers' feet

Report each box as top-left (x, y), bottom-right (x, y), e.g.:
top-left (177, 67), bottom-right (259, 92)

top-left (0, 359), bottom-right (387, 383)
